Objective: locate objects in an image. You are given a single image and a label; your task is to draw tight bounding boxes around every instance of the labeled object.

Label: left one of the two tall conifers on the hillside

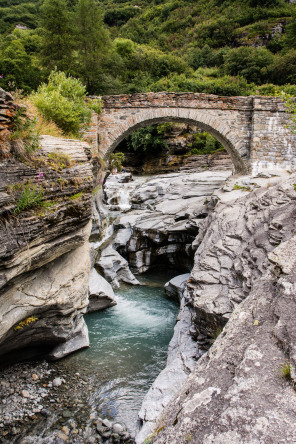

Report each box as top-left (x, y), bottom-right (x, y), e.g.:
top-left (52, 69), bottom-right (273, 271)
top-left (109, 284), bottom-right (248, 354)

top-left (41, 0), bottom-right (73, 73)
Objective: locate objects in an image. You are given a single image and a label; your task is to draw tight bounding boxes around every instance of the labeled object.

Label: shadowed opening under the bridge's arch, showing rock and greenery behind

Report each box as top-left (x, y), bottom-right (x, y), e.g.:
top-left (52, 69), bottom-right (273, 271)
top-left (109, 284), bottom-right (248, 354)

top-left (112, 122), bottom-right (233, 175)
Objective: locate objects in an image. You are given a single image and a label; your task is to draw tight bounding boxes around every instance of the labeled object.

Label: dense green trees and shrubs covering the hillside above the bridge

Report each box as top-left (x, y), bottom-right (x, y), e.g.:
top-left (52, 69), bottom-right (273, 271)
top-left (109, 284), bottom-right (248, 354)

top-left (0, 0), bottom-right (296, 95)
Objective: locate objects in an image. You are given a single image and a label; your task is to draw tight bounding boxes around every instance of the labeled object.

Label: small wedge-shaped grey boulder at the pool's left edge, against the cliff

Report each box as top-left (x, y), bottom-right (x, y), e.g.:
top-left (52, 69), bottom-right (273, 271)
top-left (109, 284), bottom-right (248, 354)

top-left (87, 268), bottom-right (116, 313)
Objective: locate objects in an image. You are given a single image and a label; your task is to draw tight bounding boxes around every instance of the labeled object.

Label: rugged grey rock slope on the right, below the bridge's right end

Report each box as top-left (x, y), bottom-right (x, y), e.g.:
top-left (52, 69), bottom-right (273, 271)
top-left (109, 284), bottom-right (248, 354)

top-left (151, 176), bottom-right (296, 444)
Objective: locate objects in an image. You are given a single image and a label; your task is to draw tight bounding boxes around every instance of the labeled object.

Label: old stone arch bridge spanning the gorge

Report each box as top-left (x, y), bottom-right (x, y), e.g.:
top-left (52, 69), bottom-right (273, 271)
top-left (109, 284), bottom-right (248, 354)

top-left (87, 92), bottom-right (296, 174)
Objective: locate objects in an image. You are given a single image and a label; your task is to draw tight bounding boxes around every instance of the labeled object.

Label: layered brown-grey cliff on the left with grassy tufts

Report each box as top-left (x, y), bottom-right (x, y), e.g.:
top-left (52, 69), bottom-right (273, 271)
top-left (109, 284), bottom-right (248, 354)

top-left (0, 90), bottom-right (93, 357)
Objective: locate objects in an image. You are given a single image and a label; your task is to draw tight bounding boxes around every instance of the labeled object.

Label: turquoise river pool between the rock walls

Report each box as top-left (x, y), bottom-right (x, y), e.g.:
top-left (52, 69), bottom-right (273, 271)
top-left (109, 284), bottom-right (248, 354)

top-left (64, 275), bottom-right (178, 432)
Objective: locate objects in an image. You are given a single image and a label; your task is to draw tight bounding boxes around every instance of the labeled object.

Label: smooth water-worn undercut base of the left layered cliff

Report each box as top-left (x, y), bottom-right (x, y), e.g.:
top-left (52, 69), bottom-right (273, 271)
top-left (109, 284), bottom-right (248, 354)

top-left (0, 236), bottom-right (90, 359)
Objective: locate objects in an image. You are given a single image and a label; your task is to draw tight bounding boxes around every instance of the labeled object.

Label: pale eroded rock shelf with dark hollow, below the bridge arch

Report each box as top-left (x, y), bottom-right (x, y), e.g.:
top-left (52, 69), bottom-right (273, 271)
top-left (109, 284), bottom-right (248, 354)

top-left (99, 171), bottom-right (230, 281)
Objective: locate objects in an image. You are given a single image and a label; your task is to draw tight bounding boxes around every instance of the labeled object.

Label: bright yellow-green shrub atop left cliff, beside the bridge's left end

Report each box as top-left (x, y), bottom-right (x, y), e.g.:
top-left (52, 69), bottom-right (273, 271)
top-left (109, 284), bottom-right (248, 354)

top-left (32, 70), bottom-right (91, 136)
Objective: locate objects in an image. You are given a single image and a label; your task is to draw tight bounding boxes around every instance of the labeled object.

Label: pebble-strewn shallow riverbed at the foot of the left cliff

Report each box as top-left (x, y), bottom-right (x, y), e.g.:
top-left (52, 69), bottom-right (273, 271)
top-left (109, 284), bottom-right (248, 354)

top-left (0, 361), bottom-right (134, 444)
